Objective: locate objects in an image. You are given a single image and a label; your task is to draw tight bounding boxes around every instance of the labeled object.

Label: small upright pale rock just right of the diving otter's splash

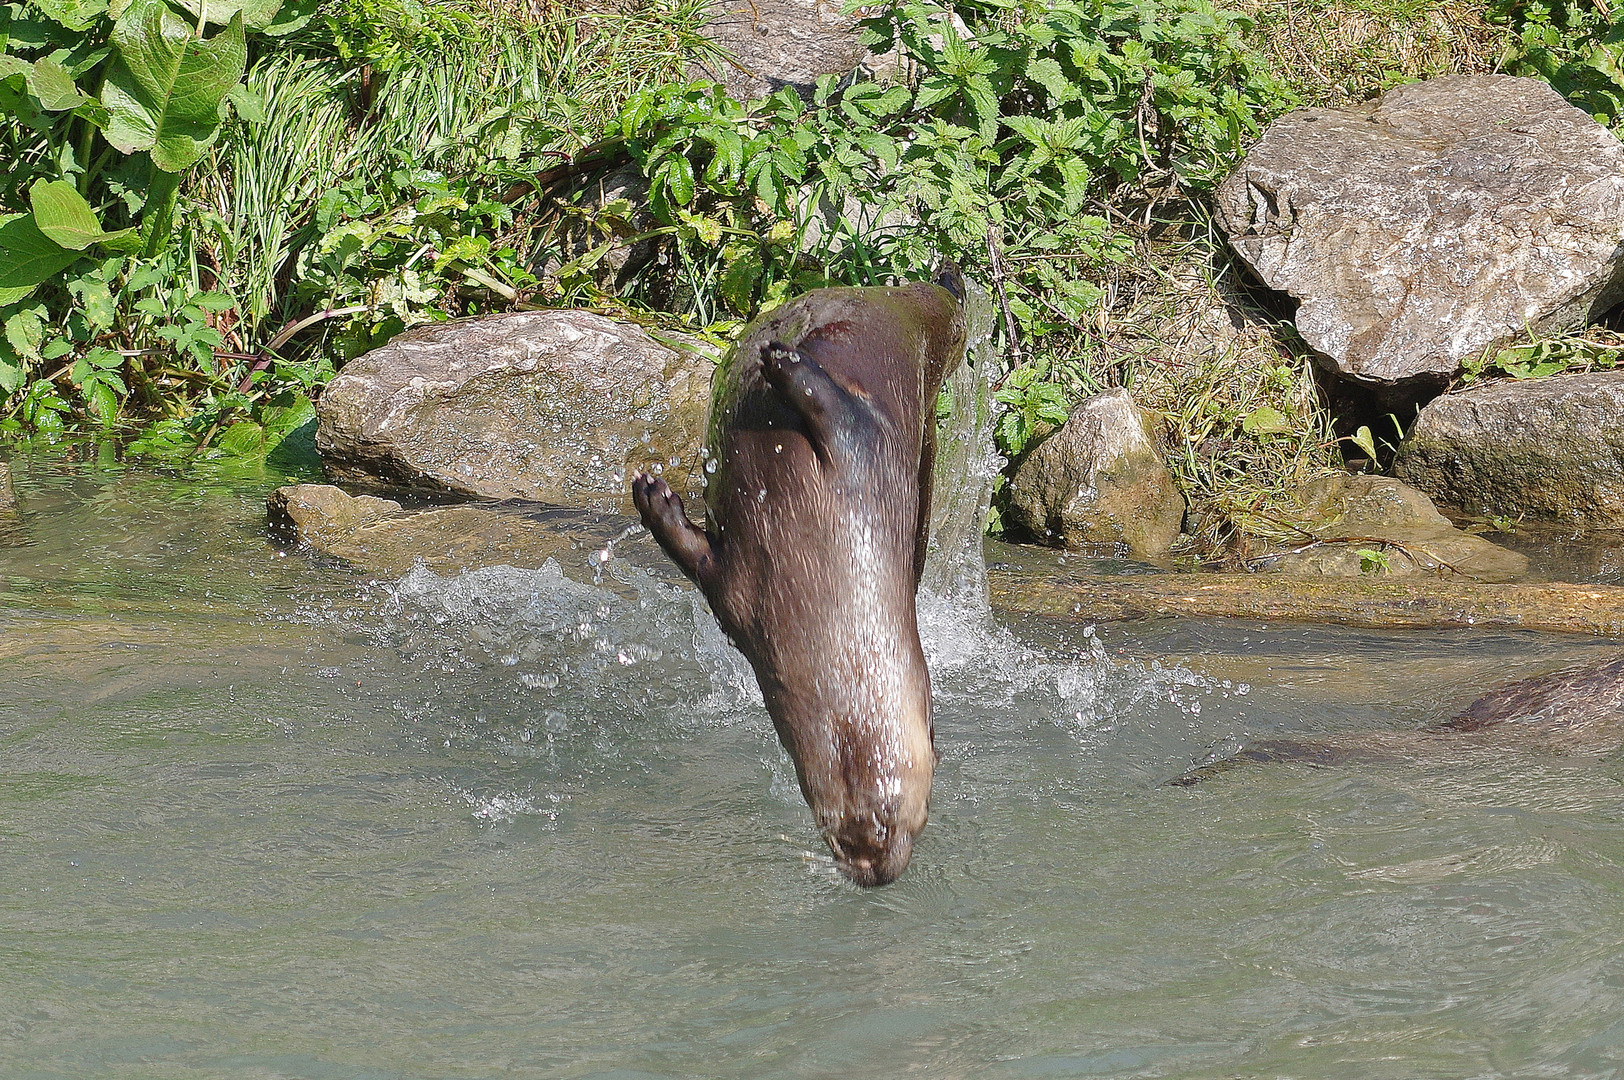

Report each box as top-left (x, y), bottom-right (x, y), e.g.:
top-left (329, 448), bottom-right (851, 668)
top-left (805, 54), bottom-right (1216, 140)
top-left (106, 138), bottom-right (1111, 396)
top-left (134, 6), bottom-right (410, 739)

top-left (1010, 388), bottom-right (1184, 559)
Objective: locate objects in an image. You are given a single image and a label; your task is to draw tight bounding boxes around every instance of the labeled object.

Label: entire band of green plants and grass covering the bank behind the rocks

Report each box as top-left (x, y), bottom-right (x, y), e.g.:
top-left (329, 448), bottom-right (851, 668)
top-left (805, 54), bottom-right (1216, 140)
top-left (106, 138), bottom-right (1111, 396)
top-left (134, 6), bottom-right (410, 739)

top-left (0, 0), bottom-right (1624, 557)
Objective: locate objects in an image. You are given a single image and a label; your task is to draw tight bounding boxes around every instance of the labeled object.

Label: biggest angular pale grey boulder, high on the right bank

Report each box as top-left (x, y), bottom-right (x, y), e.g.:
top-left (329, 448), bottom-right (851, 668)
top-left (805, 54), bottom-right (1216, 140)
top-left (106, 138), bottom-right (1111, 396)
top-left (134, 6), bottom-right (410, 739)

top-left (1216, 75), bottom-right (1624, 383)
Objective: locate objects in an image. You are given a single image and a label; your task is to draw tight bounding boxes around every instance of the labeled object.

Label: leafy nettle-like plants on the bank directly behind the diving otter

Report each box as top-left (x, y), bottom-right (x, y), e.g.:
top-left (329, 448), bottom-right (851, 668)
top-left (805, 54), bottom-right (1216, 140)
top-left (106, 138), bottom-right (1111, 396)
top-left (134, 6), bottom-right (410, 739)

top-left (587, 0), bottom-right (1289, 425)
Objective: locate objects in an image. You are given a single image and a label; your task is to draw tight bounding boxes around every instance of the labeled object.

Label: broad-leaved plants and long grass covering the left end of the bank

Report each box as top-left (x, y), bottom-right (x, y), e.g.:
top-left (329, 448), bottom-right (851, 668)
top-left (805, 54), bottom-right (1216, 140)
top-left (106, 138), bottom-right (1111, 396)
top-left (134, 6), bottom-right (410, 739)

top-left (0, 0), bottom-right (708, 441)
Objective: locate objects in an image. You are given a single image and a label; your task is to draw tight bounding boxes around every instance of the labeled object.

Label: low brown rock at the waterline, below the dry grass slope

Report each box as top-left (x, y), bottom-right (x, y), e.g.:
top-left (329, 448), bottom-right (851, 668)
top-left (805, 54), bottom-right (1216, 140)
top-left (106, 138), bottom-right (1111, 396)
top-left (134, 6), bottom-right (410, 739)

top-left (1257, 474), bottom-right (1528, 581)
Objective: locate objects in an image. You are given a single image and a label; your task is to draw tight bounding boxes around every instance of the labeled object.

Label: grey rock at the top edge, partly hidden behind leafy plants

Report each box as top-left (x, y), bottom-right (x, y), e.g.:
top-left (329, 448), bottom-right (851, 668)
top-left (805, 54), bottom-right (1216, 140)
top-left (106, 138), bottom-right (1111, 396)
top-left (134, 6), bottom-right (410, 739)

top-left (702, 0), bottom-right (869, 101)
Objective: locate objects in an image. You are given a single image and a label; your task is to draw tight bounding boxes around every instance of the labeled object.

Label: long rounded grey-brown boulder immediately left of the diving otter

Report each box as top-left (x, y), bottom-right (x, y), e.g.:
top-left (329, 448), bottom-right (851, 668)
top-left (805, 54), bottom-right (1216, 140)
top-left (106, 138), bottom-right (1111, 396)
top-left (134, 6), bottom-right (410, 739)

top-left (317, 310), bottom-right (713, 510)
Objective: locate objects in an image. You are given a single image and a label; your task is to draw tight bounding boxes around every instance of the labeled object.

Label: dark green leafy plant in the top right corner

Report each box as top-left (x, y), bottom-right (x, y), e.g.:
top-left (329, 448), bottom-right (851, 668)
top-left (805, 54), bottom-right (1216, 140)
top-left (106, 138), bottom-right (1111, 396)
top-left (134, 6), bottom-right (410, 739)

top-left (1489, 0), bottom-right (1624, 123)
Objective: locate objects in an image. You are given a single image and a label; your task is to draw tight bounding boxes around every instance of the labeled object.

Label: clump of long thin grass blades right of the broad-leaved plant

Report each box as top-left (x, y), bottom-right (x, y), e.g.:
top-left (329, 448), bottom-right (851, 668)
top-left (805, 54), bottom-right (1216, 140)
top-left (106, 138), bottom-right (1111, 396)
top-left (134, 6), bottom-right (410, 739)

top-left (185, 0), bottom-right (708, 349)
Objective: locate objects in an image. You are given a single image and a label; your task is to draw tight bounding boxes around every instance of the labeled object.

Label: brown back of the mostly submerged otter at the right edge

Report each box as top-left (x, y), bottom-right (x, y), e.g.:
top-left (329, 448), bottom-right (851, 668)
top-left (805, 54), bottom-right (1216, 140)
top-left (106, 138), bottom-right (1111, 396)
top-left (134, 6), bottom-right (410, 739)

top-left (1168, 656), bottom-right (1624, 788)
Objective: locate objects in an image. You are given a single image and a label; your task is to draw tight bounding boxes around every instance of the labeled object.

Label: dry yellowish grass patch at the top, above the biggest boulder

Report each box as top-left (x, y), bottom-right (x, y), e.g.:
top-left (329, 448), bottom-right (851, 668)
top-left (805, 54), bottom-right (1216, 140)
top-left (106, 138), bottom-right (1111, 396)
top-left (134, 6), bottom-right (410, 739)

top-left (1241, 0), bottom-right (1505, 107)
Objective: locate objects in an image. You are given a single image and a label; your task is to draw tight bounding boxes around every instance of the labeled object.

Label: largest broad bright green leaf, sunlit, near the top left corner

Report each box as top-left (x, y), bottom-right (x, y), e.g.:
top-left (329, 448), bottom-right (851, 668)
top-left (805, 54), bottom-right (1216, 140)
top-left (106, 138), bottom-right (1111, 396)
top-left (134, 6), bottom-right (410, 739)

top-left (102, 0), bottom-right (248, 172)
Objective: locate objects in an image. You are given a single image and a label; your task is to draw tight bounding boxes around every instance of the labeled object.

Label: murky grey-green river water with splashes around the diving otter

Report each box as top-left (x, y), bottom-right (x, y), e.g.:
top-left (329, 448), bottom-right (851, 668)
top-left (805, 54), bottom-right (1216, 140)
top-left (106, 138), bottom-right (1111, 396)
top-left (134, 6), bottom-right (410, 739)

top-left (0, 441), bottom-right (1624, 1080)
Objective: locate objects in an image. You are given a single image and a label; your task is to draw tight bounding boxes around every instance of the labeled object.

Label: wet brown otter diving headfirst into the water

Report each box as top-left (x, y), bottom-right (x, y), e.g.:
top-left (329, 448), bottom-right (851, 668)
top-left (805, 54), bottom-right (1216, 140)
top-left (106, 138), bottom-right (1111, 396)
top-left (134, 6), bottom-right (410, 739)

top-left (632, 270), bottom-right (965, 887)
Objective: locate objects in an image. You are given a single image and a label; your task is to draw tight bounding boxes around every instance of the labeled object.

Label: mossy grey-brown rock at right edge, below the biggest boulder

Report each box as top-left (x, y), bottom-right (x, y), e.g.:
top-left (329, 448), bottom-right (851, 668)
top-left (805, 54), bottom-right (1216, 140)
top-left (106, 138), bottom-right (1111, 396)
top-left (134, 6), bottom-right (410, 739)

top-left (1395, 372), bottom-right (1624, 529)
